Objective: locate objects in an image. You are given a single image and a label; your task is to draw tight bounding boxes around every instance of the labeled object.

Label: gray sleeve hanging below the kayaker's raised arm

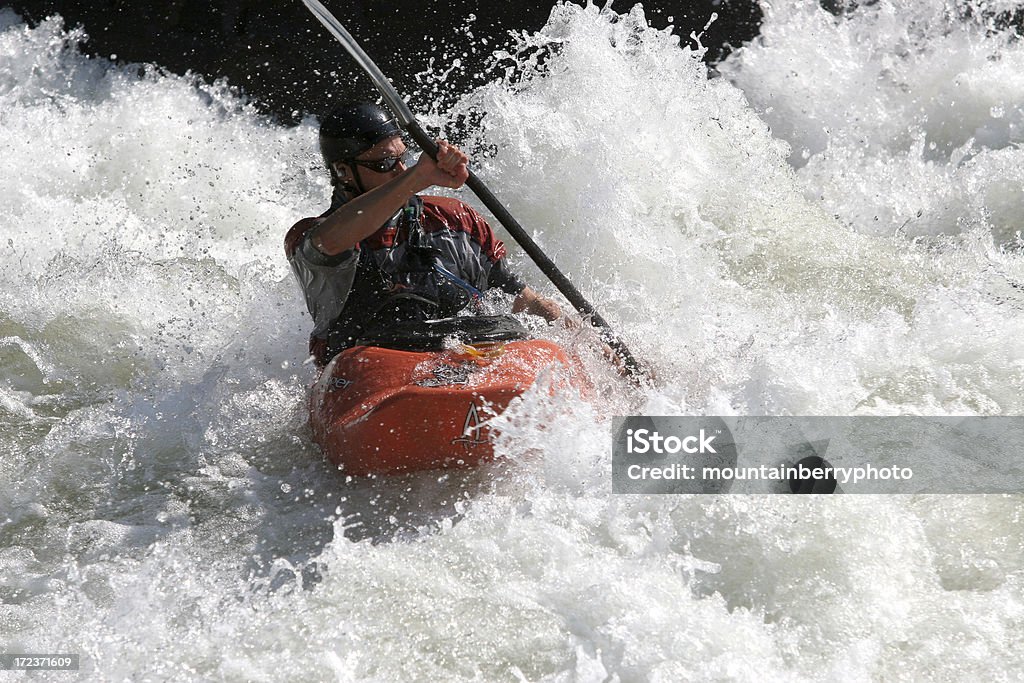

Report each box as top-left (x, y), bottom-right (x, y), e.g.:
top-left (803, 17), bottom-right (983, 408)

top-left (289, 232), bottom-right (359, 337)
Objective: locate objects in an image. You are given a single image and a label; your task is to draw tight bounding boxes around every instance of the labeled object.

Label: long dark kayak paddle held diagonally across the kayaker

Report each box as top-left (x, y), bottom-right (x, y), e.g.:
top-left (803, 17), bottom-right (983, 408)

top-left (302, 0), bottom-right (649, 381)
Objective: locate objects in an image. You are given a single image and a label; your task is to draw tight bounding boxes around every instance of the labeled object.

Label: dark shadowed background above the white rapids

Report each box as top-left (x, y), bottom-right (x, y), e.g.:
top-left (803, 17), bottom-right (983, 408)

top-left (6, 0), bottom-right (761, 123)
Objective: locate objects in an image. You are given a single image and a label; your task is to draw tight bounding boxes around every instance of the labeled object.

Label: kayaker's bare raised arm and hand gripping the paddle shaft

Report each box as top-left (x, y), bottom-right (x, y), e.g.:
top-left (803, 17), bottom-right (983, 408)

top-left (310, 140), bottom-right (469, 256)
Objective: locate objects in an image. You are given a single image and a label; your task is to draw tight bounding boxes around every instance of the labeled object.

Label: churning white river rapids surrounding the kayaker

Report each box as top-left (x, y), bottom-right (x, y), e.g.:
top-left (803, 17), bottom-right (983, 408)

top-left (0, 0), bottom-right (1024, 681)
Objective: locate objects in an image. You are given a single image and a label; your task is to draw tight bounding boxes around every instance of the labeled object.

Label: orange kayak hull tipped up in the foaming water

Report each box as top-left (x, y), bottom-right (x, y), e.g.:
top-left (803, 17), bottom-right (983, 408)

top-left (310, 318), bottom-right (573, 475)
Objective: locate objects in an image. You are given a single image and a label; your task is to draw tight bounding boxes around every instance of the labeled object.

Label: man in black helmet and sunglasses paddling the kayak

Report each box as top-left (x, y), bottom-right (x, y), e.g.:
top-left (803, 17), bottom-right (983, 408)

top-left (285, 103), bottom-right (561, 366)
